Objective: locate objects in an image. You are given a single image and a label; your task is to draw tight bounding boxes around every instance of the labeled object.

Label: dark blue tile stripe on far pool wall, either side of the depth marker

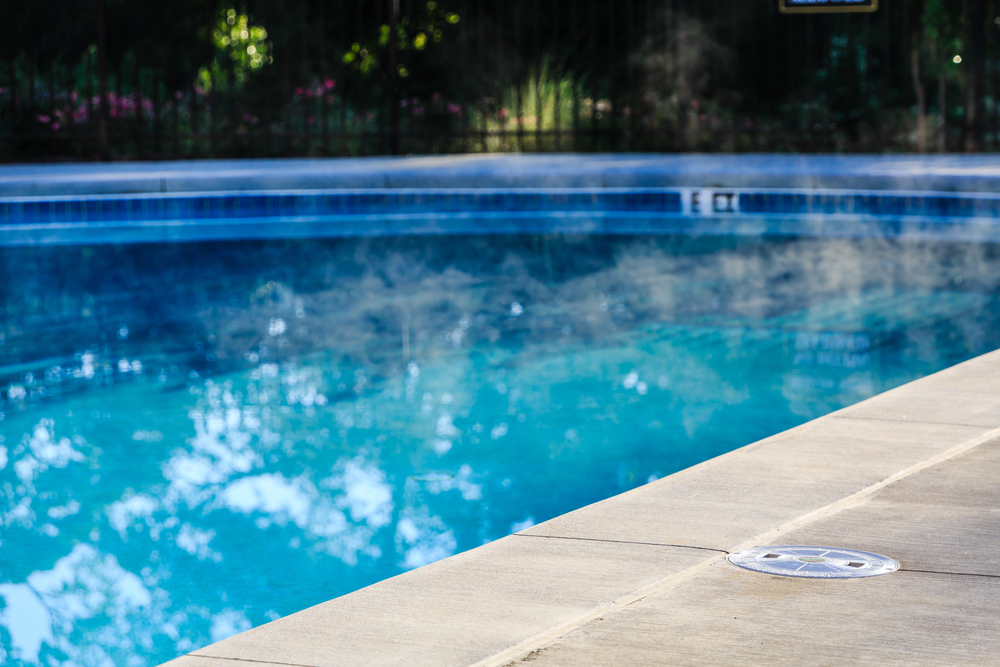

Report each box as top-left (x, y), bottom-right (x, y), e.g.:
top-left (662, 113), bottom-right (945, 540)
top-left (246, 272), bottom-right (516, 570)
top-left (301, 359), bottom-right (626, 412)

top-left (0, 189), bottom-right (1000, 225)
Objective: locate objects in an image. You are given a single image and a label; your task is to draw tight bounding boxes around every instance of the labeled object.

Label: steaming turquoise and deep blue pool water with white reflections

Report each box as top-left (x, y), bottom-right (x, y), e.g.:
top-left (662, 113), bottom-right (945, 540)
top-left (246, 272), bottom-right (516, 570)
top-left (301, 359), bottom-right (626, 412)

top-left (0, 235), bottom-right (1000, 665)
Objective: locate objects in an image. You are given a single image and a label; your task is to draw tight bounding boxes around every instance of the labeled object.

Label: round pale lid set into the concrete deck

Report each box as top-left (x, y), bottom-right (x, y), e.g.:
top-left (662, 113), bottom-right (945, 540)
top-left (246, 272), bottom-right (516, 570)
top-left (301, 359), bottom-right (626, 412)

top-left (729, 546), bottom-right (899, 579)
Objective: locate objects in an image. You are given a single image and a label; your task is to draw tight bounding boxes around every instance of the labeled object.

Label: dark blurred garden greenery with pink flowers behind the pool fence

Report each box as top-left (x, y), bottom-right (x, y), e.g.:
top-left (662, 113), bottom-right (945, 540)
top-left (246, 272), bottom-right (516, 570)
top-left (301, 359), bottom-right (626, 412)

top-left (0, 0), bottom-right (1000, 162)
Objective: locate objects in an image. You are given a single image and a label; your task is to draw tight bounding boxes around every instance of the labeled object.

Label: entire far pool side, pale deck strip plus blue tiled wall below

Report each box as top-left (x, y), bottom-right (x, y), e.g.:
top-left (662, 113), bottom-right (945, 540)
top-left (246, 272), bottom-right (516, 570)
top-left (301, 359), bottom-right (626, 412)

top-left (0, 155), bottom-right (1000, 246)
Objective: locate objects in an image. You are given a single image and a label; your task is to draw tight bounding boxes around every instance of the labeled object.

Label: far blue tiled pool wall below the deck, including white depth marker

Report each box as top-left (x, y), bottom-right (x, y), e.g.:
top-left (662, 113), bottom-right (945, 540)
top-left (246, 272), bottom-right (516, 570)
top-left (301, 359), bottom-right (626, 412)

top-left (0, 187), bottom-right (1000, 246)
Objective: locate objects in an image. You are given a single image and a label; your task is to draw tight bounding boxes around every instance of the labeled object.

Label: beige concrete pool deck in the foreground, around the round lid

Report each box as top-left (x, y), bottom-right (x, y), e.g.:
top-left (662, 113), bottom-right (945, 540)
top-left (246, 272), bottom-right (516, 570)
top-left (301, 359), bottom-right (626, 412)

top-left (167, 351), bottom-right (1000, 667)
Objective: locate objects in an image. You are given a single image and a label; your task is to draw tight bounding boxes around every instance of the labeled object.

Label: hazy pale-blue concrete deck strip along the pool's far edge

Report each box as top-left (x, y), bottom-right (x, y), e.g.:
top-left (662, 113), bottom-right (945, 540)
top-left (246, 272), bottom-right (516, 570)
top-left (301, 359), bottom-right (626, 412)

top-left (0, 153), bottom-right (1000, 197)
